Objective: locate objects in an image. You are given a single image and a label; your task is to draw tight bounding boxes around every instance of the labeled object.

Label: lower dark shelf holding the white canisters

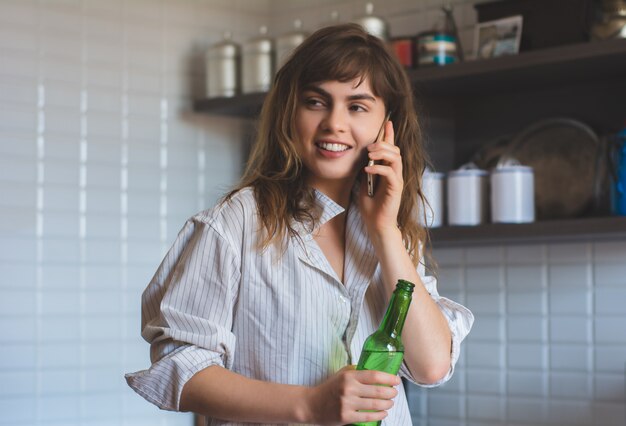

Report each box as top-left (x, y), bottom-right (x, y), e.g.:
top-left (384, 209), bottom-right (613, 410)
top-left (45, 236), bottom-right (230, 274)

top-left (430, 216), bottom-right (626, 248)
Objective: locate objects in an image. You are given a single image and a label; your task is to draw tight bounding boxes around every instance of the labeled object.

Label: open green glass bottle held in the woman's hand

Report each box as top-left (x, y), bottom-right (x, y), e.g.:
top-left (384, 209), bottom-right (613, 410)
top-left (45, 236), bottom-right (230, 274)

top-left (354, 280), bottom-right (415, 426)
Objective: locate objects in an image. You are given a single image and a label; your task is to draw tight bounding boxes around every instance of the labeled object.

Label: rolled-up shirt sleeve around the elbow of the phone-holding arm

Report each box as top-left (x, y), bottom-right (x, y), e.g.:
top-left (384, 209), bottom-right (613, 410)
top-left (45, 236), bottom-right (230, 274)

top-left (401, 262), bottom-right (474, 387)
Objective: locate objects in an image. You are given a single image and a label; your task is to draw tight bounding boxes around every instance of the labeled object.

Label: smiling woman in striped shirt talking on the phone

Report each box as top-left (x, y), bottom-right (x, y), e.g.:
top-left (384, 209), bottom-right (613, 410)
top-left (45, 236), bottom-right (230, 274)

top-left (127, 25), bottom-right (473, 426)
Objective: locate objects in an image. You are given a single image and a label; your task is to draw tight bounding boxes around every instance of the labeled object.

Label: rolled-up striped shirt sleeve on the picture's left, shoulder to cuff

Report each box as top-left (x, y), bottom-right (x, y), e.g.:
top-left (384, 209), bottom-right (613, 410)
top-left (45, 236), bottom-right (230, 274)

top-left (125, 217), bottom-right (240, 411)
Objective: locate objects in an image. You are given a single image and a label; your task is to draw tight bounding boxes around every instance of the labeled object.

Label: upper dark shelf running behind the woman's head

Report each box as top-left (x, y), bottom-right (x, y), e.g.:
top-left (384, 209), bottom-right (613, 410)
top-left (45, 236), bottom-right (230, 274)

top-left (194, 40), bottom-right (626, 118)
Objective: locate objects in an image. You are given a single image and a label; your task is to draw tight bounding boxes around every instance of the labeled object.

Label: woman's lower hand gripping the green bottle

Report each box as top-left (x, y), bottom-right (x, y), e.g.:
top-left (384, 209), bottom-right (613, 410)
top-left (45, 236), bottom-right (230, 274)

top-left (307, 365), bottom-right (401, 425)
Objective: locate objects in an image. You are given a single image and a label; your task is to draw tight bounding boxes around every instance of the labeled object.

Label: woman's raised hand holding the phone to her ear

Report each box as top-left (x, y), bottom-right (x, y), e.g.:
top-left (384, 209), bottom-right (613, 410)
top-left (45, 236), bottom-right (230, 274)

top-left (359, 121), bottom-right (404, 234)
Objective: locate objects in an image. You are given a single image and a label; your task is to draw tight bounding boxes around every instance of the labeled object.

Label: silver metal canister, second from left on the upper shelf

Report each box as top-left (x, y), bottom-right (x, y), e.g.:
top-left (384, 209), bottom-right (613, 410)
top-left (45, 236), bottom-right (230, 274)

top-left (241, 26), bottom-right (274, 93)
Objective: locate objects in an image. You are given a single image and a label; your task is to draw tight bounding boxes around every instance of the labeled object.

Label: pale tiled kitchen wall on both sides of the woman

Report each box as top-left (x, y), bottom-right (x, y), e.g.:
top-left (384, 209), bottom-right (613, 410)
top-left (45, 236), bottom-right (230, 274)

top-left (0, 0), bottom-right (626, 426)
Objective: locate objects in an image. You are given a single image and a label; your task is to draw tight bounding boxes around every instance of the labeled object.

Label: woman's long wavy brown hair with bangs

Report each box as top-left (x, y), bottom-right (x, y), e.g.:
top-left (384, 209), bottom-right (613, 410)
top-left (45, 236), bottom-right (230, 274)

top-left (225, 24), bottom-right (428, 265)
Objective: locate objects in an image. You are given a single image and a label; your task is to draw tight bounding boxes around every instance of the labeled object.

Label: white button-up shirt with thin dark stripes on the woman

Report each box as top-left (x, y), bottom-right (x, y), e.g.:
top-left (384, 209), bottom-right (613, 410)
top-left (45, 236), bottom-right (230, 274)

top-left (126, 188), bottom-right (473, 426)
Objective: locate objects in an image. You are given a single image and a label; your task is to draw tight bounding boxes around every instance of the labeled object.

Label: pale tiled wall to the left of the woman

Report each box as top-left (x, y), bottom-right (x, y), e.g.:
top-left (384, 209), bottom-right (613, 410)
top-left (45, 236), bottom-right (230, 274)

top-left (0, 0), bottom-right (258, 426)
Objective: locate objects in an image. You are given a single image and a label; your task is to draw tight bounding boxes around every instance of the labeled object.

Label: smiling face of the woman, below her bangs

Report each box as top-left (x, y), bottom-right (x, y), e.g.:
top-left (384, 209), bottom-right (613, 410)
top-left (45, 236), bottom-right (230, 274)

top-left (296, 78), bottom-right (385, 193)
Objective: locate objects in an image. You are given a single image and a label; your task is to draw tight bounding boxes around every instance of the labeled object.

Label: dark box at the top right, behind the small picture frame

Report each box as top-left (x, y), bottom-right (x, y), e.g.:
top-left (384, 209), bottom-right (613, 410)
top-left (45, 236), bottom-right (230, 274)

top-left (474, 0), bottom-right (593, 51)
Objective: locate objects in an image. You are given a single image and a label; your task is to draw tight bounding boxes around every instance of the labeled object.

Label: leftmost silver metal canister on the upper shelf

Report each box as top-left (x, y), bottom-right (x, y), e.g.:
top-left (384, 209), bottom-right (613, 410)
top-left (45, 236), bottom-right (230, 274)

top-left (206, 33), bottom-right (240, 98)
